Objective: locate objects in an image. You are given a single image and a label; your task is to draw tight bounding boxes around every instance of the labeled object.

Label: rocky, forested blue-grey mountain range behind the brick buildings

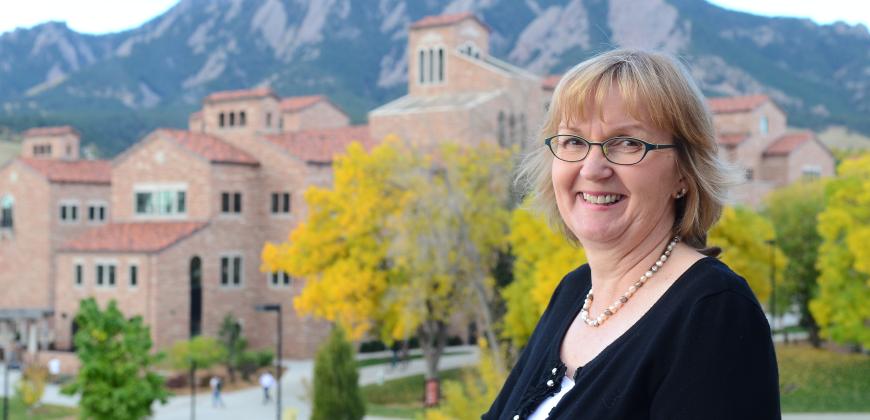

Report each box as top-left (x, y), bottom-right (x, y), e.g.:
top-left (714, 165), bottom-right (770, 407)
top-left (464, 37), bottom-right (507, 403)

top-left (0, 0), bottom-right (870, 155)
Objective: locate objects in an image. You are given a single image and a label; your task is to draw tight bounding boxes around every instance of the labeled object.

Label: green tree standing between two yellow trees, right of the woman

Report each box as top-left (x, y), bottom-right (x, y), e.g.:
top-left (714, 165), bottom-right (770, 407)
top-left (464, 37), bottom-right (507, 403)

top-left (765, 181), bottom-right (825, 347)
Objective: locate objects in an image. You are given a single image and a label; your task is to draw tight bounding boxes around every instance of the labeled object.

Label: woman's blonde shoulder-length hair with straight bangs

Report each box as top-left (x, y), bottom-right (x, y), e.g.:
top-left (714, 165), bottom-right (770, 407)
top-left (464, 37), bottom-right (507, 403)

top-left (517, 49), bottom-right (735, 253)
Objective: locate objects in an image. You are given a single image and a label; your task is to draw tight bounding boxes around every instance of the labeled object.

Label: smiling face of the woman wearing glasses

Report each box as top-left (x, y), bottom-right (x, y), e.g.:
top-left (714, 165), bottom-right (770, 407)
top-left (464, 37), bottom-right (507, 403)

top-left (552, 87), bottom-right (685, 246)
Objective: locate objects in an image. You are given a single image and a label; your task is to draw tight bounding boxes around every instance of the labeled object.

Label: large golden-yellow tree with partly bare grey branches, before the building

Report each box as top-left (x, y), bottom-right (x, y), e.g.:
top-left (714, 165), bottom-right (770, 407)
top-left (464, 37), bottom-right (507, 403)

top-left (263, 141), bottom-right (510, 390)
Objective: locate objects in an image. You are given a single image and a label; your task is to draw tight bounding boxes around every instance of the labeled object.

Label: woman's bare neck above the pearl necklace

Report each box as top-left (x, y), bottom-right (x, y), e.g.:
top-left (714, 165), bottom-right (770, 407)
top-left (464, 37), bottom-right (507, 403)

top-left (583, 225), bottom-right (673, 306)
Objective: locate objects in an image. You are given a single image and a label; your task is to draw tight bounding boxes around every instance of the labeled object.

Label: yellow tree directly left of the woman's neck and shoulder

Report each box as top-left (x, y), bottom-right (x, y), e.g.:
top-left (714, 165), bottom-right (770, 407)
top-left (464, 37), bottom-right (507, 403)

top-left (502, 207), bottom-right (586, 348)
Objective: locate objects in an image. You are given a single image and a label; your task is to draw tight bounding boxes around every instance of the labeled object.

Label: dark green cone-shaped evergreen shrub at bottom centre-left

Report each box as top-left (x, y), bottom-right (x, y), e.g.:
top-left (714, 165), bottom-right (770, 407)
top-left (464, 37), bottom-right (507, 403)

top-left (311, 325), bottom-right (365, 420)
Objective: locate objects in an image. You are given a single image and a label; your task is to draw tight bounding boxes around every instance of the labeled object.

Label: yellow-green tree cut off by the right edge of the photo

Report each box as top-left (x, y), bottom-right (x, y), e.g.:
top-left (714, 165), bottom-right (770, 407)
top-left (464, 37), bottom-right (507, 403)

top-left (810, 153), bottom-right (870, 348)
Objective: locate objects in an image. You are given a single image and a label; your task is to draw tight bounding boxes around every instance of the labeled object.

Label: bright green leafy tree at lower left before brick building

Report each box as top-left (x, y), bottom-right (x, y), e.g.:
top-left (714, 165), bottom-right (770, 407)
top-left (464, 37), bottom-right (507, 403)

top-left (63, 298), bottom-right (169, 420)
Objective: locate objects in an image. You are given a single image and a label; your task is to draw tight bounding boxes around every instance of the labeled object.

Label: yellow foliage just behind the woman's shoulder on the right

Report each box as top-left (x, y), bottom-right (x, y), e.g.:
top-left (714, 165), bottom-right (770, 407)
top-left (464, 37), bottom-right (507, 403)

top-left (707, 207), bottom-right (788, 306)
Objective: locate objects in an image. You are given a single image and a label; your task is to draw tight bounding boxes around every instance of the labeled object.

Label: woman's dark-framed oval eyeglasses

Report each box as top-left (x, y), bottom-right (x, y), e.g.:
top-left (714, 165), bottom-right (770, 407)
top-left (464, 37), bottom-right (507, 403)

top-left (544, 134), bottom-right (677, 165)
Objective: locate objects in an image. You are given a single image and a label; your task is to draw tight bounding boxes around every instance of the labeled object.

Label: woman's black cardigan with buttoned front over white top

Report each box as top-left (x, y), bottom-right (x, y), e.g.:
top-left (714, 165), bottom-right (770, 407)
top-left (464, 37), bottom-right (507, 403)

top-left (482, 257), bottom-right (781, 420)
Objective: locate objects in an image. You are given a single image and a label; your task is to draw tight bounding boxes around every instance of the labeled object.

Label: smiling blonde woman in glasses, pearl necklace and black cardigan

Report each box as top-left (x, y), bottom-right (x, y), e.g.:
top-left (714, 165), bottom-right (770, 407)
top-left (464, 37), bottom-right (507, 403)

top-left (483, 50), bottom-right (780, 420)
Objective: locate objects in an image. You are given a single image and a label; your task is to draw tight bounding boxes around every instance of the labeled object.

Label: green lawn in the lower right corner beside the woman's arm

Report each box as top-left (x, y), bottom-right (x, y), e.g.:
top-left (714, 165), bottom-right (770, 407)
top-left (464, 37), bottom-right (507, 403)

top-left (776, 344), bottom-right (870, 413)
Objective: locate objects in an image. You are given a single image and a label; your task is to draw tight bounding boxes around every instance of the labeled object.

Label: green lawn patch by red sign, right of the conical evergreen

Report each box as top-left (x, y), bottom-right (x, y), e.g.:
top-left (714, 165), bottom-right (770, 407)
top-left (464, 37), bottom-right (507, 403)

top-left (362, 369), bottom-right (470, 418)
